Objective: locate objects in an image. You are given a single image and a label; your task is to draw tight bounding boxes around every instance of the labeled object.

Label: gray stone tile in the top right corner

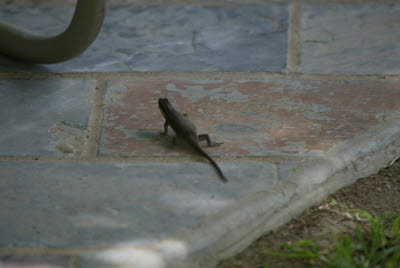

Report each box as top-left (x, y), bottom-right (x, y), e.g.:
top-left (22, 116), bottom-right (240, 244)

top-left (301, 4), bottom-right (400, 74)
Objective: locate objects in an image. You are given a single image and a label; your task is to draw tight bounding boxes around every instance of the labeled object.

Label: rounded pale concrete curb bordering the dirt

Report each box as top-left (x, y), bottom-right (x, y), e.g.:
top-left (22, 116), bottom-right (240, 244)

top-left (173, 118), bottom-right (400, 267)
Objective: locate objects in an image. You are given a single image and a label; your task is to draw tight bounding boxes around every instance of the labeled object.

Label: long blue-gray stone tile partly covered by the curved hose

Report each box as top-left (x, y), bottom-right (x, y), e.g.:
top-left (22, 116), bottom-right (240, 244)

top-left (0, 4), bottom-right (288, 72)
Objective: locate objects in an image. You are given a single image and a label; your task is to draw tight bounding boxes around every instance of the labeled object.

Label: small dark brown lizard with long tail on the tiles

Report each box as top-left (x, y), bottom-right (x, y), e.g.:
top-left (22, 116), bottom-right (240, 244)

top-left (158, 98), bottom-right (228, 182)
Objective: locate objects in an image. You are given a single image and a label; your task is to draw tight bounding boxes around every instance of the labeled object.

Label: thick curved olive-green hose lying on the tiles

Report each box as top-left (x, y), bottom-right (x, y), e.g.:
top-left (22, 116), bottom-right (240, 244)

top-left (0, 0), bottom-right (105, 63)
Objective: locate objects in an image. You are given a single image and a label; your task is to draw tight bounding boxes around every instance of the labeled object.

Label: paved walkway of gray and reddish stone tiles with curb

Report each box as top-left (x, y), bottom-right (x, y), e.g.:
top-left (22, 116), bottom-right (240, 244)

top-left (0, 0), bottom-right (400, 268)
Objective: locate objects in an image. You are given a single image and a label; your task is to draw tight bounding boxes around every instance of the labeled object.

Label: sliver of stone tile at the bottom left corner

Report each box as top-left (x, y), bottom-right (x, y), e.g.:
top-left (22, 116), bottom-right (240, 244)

top-left (0, 255), bottom-right (74, 268)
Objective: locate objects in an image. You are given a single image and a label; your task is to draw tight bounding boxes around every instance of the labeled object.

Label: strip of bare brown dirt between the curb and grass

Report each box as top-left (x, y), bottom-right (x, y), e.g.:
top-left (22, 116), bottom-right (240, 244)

top-left (217, 156), bottom-right (400, 268)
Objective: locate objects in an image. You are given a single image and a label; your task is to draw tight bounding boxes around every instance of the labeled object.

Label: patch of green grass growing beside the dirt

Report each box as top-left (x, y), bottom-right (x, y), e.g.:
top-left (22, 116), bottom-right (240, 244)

top-left (264, 210), bottom-right (400, 268)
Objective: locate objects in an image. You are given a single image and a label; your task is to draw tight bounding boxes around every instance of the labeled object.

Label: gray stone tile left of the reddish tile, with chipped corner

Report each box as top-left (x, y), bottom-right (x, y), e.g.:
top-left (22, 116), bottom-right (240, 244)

top-left (0, 79), bottom-right (96, 156)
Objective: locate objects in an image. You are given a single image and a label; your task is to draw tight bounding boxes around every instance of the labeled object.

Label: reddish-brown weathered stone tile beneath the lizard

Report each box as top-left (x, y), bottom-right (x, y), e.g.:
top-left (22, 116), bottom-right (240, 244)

top-left (100, 80), bottom-right (400, 156)
